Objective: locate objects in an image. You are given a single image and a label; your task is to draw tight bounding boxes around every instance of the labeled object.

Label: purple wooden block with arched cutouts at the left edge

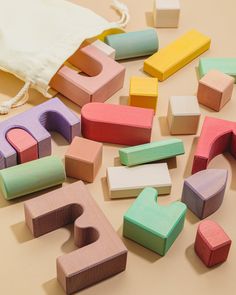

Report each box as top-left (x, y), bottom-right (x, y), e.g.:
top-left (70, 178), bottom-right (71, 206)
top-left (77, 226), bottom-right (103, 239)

top-left (0, 98), bottom-right (80, 169)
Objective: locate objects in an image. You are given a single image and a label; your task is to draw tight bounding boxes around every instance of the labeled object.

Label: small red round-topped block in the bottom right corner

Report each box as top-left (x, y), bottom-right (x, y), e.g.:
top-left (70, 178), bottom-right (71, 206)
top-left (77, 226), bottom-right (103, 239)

top-left (194, 220), bottom-right (231, 267)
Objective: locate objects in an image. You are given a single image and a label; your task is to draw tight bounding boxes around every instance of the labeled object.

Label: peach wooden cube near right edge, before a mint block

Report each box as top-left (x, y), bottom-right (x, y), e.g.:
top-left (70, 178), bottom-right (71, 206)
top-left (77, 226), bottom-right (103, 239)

top-left (197, 70), bottom-right (234, 112)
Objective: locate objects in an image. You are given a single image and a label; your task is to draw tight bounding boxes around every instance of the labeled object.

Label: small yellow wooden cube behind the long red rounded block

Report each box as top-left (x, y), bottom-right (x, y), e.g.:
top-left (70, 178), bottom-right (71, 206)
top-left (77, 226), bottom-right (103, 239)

top-left (129, 77), bottom-right (158, 112)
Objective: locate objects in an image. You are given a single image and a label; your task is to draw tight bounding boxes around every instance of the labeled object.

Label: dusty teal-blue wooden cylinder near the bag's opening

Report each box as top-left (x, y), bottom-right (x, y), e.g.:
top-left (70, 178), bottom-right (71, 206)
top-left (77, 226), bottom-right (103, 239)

top-left (104, 29), bottom-right (159, 60)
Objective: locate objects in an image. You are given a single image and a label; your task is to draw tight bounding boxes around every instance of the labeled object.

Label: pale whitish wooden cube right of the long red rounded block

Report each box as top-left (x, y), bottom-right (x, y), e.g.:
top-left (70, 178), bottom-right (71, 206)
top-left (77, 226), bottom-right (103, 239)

top-left (167, 96), bottom-right (201, 134)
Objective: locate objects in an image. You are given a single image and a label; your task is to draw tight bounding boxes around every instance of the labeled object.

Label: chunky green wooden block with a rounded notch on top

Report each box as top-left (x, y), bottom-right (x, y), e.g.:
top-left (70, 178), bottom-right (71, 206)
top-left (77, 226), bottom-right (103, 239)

top-left (123, 187), bottom-right (187, 256)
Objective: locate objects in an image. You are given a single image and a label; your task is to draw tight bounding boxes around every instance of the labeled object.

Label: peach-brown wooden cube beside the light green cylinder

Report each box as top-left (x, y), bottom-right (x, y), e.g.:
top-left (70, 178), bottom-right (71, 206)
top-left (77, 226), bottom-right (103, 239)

top-left (65, 137), bottom-right (102, 182)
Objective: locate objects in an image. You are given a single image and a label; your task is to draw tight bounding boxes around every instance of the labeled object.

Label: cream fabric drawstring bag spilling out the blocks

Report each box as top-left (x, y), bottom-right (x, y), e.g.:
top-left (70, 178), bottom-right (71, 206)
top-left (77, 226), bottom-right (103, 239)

top-left (0, 0), bottom-right (129, 114)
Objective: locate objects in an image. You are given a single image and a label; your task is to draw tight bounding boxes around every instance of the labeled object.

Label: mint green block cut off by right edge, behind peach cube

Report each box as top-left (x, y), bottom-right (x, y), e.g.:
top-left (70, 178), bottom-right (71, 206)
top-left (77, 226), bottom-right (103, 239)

top-left (198, 57), bottom-right (236, 82)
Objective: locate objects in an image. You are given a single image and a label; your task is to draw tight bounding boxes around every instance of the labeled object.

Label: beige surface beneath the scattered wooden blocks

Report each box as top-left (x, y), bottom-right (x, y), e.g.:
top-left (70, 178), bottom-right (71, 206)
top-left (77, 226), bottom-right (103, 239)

top-left (0, 0), bottom-right (236, 295)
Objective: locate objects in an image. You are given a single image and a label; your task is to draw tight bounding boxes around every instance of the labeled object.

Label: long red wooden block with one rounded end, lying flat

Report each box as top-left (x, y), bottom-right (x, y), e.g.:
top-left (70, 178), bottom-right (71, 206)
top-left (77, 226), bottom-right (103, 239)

top-left (81, 103), bottom-right (154, 145)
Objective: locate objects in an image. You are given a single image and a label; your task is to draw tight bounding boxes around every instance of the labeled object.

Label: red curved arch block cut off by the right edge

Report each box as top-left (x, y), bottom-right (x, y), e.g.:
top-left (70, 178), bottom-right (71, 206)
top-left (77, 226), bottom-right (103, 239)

top-left (192, 117), bottom-right (236, 174)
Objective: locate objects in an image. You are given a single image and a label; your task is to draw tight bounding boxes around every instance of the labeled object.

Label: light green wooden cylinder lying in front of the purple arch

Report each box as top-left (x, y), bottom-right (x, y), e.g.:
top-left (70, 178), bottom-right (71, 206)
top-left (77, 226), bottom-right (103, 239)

top-left (0, 156), bottom-right (66, 200)
